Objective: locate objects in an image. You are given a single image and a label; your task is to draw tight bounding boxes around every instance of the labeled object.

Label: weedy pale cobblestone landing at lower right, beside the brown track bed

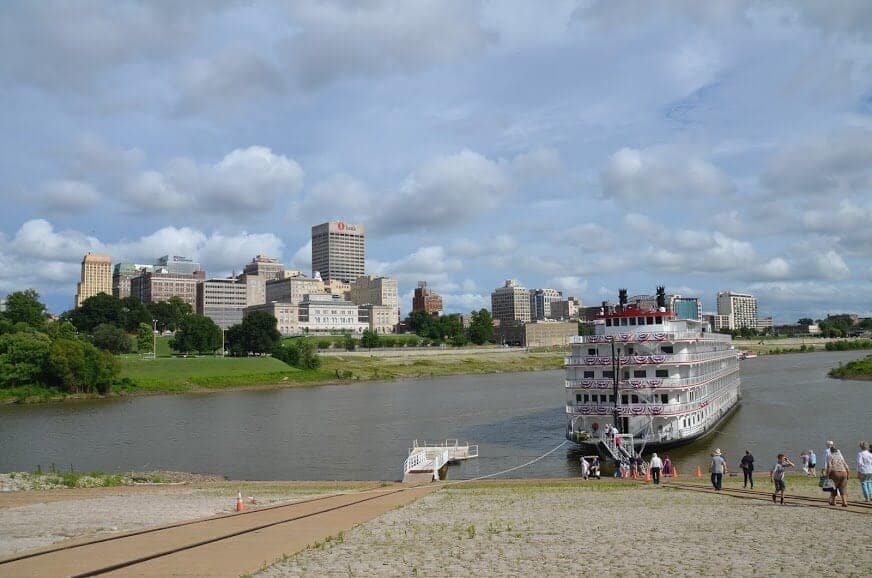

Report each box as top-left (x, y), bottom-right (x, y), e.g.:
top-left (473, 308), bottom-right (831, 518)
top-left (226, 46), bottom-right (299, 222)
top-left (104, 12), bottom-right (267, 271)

top-left (257, 484), bottom-right (872, 577)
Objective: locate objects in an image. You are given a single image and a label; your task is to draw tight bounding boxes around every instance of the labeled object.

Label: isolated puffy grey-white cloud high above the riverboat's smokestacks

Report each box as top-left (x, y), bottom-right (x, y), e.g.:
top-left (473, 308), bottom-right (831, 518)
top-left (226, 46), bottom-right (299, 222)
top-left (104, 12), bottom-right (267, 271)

top-left (600, 148), bottom-right (733, 204)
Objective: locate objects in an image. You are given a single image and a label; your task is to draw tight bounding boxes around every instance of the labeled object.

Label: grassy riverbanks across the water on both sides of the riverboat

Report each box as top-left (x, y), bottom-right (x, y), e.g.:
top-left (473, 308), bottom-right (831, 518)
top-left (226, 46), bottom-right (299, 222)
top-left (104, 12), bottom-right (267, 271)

top-left (0, 335), bottom-right (872, 404)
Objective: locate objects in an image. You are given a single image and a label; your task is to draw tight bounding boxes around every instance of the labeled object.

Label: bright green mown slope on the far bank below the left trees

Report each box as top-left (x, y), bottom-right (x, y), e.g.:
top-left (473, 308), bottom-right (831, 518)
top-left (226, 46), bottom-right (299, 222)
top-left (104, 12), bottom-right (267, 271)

top-left (120, 356), bottom-right (329, 392)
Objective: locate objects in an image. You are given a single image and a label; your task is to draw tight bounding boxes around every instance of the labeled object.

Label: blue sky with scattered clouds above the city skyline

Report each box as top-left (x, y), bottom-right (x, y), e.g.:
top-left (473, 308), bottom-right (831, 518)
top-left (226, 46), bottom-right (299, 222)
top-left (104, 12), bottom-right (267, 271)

top-left (0, 0), bottom-right (872, 323)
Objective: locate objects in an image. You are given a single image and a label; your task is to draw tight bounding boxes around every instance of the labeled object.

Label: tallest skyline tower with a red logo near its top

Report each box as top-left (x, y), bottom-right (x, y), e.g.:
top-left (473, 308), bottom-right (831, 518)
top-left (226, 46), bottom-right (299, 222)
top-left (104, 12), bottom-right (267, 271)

top-left (312, 221), bottom-right (366, 283)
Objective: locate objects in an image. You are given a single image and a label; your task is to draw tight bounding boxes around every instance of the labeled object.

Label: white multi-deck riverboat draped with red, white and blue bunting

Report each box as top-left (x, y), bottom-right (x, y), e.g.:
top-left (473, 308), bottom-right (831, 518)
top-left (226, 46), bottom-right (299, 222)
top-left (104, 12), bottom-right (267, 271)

top-left (564, 287), bottom-right (741, 462)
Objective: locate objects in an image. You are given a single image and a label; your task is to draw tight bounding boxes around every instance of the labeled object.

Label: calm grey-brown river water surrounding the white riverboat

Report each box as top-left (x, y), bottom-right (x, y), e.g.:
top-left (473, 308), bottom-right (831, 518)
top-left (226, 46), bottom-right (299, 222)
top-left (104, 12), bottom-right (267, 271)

top-left (0, 352), bottom-right (872, 480)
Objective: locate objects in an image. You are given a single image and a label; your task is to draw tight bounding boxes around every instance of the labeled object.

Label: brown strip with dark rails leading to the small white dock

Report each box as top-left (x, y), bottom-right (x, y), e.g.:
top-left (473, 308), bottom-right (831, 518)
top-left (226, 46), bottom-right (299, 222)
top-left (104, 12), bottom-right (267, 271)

top-left (0, 486), bottom-right (436, 576)
